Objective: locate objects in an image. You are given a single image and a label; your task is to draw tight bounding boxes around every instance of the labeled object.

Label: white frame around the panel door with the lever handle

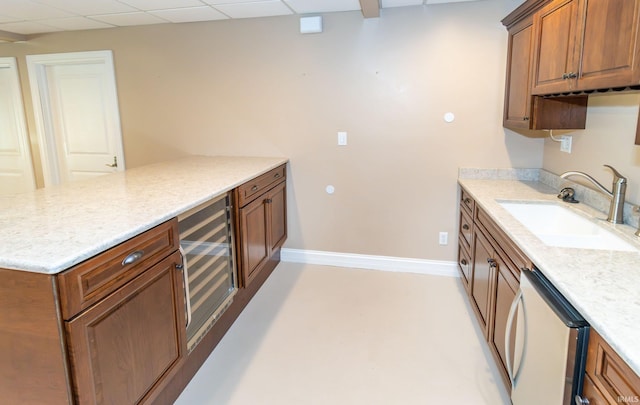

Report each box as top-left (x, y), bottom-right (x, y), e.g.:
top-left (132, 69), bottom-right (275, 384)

top-left (26, 50), bottom-right (125, 187)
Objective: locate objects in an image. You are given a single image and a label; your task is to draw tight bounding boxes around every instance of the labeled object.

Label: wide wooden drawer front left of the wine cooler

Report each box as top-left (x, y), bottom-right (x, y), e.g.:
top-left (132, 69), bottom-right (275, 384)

top-left (58, 219), bottom-right (179, 320)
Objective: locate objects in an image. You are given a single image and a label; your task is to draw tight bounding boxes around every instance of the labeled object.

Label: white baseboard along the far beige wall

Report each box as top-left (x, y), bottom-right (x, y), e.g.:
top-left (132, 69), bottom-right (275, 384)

top-left (280, 248), bottom-right (459, 277)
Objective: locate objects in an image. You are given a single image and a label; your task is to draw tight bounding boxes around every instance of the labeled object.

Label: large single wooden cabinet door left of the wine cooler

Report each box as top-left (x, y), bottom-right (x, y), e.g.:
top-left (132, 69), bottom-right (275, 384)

top-left (66, 253), bottom-right (185, 405)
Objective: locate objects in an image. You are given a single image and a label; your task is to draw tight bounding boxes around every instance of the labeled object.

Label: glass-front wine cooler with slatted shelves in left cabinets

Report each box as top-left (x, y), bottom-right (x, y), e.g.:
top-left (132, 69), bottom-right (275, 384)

top-left (178, 193), bottom-right (238, 351)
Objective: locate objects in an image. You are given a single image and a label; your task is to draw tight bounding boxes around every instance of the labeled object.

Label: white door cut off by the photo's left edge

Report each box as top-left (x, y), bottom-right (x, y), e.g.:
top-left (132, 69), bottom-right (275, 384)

top-left (0, 58), bottom-right (36, 195)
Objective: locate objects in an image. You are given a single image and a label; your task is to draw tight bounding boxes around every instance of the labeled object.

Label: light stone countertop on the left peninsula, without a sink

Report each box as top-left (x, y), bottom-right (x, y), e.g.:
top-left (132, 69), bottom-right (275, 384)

top-left (0, 156), bottom-right (287, 274)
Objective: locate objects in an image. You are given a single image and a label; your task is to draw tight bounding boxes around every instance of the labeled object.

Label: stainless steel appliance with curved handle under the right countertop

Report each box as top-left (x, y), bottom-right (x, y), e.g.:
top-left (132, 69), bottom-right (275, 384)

top-left (505, 267), bottom-right (589, 405)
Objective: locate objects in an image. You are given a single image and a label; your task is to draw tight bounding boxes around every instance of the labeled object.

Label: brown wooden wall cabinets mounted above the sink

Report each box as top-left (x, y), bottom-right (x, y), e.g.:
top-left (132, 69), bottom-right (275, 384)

top-left (502, 0), bottom-right (640, 144)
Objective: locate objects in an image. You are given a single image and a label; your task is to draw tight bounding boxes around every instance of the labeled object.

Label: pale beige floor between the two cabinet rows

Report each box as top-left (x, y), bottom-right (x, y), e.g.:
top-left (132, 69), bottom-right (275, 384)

top-left (176, 263), bottom-right (509, 405)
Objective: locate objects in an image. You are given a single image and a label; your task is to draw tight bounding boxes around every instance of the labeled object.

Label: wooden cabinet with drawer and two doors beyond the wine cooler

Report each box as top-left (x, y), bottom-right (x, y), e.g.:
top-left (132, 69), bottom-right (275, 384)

top-left (236, 165), bottom-right (287, 287)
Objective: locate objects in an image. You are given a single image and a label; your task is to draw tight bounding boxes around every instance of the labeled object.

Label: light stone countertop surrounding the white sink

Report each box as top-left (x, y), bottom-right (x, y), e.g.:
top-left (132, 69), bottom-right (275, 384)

top-left (458, 178), bottom-right (640, 375)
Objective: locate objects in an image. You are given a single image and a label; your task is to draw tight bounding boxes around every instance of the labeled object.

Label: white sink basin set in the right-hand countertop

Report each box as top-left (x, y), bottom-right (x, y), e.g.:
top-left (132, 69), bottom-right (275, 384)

top-left (497, 200), bottom-right (639, 252)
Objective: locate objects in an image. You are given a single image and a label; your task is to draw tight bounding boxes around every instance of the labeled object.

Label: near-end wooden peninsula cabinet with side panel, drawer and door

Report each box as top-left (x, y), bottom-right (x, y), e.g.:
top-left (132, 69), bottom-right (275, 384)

top-left (0, 219), bottom-right (186, 405)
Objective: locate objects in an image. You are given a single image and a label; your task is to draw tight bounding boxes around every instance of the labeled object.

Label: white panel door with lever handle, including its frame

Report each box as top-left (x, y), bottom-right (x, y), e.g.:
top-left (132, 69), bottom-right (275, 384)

top-left (27, 51), bottom-right (124, 185)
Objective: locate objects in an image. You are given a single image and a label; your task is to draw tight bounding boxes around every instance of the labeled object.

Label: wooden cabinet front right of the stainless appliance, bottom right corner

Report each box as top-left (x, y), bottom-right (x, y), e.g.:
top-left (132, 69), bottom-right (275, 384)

top-left (587, 329), bottom-right (640, 403)
